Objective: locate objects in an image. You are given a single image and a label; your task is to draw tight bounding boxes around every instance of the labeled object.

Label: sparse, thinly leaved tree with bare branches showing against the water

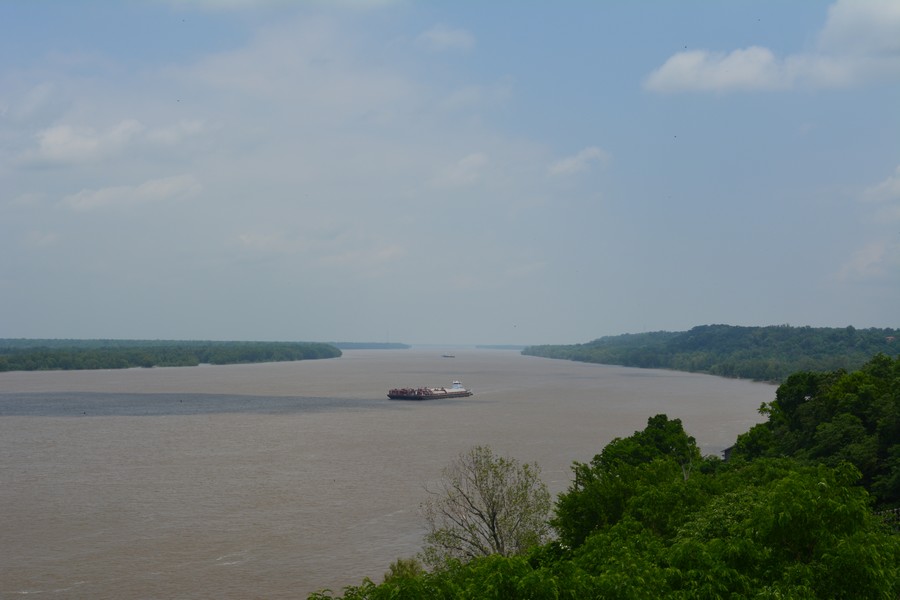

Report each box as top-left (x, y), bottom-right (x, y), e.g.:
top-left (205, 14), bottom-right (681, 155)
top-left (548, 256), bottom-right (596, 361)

top-left (421, 446), bottom-right (550, 566)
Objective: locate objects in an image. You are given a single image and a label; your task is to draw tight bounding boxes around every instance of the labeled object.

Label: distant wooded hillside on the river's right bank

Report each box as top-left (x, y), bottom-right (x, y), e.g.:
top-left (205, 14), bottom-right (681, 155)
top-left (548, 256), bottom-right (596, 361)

top-left (523, 325), bottom-right (900, 381)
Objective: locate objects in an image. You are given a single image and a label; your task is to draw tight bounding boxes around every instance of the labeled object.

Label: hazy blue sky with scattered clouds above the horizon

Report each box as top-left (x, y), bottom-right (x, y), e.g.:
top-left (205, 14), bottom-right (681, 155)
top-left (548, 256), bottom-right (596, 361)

top-left (0, 0), bottom-right (900, 344)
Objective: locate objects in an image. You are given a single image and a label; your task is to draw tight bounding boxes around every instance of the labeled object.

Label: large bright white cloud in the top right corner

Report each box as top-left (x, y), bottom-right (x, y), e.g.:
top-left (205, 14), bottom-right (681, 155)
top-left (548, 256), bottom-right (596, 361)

top-left (644, 0), bottom-right (900, 92)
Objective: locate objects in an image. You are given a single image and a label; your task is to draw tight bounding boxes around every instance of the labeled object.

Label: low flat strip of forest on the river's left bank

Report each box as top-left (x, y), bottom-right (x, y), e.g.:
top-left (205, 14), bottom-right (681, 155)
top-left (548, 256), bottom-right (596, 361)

top-left (0, 340), bottom-right (341, 371)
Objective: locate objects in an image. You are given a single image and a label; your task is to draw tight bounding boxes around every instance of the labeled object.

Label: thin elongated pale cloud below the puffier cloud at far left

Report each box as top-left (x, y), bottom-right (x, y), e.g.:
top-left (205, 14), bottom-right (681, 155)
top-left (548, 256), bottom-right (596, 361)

top-left (63, 175), bottom-right (201, 211)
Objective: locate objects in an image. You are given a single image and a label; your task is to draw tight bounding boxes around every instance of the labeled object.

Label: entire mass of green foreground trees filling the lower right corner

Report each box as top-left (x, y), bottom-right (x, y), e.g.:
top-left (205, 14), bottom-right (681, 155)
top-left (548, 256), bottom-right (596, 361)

top-left (311, 355), bottom-right (900, 600)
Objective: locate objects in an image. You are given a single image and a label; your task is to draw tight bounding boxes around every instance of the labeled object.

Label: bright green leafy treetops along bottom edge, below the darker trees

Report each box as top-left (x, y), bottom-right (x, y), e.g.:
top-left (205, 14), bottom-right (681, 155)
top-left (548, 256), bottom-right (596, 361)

top-left (312, 458), bottom-right (900, 600)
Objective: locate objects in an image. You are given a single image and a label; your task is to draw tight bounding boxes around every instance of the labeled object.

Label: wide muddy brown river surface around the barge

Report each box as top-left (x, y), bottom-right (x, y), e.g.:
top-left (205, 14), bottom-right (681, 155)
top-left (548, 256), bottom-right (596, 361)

top-left (0, 349), bottom-right (775, 599)
